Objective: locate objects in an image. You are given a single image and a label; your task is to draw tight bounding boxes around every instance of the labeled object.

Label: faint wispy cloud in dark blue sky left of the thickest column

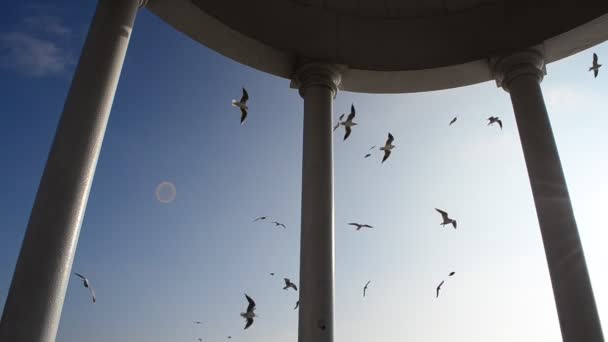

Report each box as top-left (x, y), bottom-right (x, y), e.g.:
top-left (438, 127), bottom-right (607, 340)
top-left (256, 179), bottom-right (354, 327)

top-left (0, 32), bottom-right (74, 77)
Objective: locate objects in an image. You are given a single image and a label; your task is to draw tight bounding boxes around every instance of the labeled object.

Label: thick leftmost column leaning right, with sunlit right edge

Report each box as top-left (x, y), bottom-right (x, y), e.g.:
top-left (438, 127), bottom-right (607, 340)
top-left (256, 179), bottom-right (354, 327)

top-left (0, 0), bottom-right (143, 342)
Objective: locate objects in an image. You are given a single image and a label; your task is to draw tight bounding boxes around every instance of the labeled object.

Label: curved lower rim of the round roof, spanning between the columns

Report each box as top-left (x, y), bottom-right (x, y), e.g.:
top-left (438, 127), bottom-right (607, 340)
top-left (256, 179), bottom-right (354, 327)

top-left (147, 0), bottom-right (608, 94)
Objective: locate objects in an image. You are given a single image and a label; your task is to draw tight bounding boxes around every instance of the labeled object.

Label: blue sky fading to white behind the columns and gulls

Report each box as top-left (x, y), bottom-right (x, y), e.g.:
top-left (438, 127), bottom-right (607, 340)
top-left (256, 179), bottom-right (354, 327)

top-left (0, 1), bottom-right (608, 342)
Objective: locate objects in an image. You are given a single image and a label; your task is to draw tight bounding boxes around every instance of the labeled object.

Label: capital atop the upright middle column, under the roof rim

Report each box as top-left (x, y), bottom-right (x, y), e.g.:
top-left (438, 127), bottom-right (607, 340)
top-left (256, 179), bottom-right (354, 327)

top-left (289, 63), bottom-right (342, 97)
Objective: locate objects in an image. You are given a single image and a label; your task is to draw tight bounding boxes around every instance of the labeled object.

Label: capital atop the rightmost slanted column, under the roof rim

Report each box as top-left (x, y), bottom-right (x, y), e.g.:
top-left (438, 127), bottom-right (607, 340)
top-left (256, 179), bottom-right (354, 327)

top-left (490, 48), bottom-right (547, 92)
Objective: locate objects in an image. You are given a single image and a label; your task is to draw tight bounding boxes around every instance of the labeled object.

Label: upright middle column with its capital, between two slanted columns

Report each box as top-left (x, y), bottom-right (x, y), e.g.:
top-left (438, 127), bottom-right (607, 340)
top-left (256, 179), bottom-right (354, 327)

top-left (293, 64), bottom-right (340, 342)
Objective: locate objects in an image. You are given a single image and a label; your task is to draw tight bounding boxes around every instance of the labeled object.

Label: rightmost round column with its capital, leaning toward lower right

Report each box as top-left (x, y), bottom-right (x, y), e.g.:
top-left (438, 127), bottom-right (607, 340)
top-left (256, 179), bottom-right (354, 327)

top-left (495, 50), bottom-right (604, 342)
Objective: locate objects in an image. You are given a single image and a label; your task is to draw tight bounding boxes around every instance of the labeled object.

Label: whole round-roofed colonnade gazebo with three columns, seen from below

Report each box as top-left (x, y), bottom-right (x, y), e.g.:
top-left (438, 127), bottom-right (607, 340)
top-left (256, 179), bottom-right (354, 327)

top-left (0, 0), bottom-right (608, 342)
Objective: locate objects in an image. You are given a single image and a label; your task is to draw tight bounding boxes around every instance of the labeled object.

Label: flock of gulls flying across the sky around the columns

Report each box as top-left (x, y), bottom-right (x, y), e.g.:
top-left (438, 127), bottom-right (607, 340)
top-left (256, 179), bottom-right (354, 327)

top-left (63, 53), bottom-right (602, 342)
